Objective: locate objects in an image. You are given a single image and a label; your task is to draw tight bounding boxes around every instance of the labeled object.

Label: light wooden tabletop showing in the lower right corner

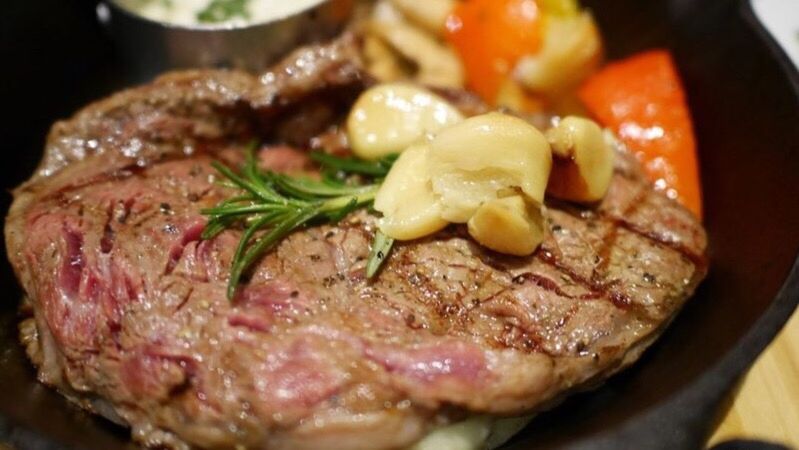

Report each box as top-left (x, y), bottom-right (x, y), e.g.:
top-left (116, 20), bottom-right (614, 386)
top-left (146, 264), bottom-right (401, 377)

top-left (708, 306), bottom-right (799, 449)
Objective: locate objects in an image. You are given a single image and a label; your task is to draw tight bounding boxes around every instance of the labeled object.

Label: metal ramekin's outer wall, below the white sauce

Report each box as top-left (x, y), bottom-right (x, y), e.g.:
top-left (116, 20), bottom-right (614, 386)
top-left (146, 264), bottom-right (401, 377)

top-left (97, 0), bottom-right (353, 81)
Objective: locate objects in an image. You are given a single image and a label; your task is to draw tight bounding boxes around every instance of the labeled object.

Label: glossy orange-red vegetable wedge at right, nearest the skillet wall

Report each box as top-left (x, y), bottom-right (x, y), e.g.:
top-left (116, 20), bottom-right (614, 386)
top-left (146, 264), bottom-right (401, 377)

top-left (579, 50), bottom-right (702, 217)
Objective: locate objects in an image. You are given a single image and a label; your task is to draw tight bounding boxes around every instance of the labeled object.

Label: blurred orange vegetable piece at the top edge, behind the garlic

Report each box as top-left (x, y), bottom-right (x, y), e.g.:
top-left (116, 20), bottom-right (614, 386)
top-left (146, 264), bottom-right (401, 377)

top-left (446, 0), bottom-right (541, 103)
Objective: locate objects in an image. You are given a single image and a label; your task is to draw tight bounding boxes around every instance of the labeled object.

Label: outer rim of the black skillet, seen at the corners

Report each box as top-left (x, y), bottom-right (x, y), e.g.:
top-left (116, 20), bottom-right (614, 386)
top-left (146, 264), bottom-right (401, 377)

top-left (0, 0), bottom-right (799, 450)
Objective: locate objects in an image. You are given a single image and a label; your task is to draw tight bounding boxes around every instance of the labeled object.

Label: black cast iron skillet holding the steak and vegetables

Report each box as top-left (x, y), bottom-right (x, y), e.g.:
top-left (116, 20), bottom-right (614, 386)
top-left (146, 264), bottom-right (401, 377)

top-left (0, 0), bottom-right (799, 450)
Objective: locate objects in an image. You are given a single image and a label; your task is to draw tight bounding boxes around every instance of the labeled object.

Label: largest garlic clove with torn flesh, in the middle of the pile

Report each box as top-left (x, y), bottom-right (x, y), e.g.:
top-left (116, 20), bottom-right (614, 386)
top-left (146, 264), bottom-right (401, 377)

top-left (429, 113), bottom-right (552, 223)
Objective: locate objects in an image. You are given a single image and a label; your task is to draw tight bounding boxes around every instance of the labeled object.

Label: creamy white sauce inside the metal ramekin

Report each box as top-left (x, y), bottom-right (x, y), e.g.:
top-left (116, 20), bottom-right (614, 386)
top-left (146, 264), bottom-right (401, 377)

top-left (114, 0), bottom-right (324, 26)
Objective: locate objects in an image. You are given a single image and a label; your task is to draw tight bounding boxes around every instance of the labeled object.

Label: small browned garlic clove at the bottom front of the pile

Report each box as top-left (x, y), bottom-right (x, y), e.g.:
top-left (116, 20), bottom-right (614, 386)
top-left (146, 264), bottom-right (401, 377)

top-left (468, 195), bottom-right (545, 256)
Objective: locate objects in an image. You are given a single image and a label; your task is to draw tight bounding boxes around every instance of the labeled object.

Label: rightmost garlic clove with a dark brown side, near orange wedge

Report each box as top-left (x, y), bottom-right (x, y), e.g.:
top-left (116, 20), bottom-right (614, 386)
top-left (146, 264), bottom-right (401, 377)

top-left (547, 116), bottom-right (614, 202)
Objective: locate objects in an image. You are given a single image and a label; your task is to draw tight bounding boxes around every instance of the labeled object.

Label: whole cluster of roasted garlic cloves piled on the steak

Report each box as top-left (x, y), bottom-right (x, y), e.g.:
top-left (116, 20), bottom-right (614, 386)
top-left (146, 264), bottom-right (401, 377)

top-left (348, 84), bottom-right (614, 256)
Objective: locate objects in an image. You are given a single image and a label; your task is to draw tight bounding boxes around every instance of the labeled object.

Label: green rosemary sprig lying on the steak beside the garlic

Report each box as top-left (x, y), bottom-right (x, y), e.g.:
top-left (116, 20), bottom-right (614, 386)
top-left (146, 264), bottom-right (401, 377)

top-left (202, 145), bottom-right (396, 299)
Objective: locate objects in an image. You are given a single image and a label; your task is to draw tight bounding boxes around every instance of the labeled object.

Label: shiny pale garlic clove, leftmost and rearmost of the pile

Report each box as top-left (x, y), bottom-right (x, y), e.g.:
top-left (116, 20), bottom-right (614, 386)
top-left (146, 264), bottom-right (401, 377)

top-left (347, 83), bottom-right (463, 159)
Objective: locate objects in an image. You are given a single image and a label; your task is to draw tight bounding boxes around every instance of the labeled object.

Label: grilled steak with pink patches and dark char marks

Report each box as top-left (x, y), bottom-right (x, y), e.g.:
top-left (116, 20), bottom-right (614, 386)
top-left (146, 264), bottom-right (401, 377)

top-left (5, 38), bottom-right (706, 449)
